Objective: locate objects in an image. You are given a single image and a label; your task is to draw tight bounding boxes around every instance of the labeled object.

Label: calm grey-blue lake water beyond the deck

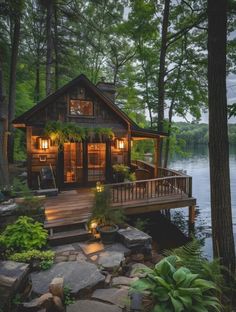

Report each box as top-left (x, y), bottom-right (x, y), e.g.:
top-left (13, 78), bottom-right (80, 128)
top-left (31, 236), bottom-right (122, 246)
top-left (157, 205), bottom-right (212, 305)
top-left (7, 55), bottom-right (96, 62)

top-left (169, 145), bottom-right (236, 257)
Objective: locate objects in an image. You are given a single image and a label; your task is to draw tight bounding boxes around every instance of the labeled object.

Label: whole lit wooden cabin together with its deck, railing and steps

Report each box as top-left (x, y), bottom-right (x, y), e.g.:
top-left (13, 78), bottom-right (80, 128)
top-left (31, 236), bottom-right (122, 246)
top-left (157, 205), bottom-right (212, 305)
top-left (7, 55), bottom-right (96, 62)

top-left (13, 75), bottom-right (196, 242)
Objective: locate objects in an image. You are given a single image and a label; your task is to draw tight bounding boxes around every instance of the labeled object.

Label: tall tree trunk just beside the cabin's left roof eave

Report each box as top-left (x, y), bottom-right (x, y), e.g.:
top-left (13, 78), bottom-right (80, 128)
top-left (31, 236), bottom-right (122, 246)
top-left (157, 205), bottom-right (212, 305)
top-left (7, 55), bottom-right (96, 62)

top-left (8, 14), bottom-right (20, 163)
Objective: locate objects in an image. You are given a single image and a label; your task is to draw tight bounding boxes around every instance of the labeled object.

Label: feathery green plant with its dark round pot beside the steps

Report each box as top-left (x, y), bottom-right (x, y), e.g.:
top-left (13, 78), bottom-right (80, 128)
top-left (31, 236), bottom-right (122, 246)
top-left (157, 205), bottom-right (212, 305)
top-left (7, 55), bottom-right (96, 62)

top-left (91, 187), bottom-right (124, 244)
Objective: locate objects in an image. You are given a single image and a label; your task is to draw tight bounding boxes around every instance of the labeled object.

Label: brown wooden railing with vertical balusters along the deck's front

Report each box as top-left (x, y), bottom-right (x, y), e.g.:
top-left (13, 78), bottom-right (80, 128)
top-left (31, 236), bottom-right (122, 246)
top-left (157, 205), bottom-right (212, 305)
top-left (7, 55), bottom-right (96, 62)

top-left (109, 176), bottom-right (192, 204)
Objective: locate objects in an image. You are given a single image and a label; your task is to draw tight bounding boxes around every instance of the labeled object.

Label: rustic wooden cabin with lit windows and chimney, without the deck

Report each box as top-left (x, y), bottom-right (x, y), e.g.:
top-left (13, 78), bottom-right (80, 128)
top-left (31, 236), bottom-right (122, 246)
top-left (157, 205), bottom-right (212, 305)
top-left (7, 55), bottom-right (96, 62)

top-left (13, 75), bottom-right (164, 189)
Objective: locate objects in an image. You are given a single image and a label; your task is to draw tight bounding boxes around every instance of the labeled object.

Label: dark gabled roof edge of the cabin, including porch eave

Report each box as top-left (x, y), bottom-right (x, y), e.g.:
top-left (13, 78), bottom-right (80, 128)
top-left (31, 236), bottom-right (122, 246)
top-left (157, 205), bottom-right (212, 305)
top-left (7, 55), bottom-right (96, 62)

top-left (12, 74), bottom-right (167, 138)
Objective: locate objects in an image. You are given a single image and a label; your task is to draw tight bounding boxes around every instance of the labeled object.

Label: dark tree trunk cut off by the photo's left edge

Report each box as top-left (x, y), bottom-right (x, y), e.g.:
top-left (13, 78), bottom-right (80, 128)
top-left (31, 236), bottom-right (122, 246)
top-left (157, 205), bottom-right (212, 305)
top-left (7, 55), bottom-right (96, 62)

top-left (0, 64), bottom-right (9, 188)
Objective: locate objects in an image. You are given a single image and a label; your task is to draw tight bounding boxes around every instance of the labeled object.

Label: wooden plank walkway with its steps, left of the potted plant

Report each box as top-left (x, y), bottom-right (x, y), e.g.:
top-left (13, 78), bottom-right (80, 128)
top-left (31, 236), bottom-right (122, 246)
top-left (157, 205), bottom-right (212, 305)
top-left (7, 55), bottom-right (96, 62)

top-left (44, 189), bottom-right (93, 245)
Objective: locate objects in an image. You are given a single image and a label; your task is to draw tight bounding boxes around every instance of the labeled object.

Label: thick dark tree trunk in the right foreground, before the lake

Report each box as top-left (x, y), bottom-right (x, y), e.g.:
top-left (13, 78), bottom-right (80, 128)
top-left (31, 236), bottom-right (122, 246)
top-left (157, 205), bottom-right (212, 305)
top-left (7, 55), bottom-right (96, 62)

top-left (208, 0), bottom-right (235, 273)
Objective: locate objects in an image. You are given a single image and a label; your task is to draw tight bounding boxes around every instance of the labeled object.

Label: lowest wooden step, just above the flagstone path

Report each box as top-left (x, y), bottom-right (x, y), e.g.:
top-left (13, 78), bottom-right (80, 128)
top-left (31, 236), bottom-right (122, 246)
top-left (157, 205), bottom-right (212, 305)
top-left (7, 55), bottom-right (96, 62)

top-left (49, 229), bottom-right (92, 246)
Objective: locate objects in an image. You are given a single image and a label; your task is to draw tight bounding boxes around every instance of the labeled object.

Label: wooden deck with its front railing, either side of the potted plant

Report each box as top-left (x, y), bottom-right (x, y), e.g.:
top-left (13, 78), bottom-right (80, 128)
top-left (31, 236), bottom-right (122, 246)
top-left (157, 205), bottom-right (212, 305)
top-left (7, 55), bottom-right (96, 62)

top-left (45, 171), bottom-right (196, 235)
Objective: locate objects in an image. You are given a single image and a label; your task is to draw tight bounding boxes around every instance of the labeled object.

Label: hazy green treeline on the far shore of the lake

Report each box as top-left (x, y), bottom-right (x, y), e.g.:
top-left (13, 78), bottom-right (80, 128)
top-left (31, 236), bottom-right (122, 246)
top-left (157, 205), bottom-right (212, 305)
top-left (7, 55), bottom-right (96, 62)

top-left (174, 122), bottom-right (236, 145)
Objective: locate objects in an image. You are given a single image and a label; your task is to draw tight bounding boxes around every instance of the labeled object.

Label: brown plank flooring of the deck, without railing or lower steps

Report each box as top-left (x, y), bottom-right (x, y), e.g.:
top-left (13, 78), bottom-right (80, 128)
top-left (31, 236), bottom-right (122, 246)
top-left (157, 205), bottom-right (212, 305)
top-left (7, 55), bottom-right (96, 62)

top-left (45, 188), bottom-right (196, 228)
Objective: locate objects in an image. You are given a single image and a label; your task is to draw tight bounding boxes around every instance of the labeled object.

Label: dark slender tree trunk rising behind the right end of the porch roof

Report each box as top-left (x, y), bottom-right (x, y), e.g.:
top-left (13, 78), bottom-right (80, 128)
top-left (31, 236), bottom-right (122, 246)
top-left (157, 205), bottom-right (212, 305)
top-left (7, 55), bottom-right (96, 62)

top-left (157, 0), bottom-right (170, 165)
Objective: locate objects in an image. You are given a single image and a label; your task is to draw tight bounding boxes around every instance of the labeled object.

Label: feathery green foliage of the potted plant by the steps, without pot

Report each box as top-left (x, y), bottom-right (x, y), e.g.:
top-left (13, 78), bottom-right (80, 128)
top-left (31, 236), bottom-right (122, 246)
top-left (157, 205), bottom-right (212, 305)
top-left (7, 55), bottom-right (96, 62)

top-left (91, 186), bottom-right (125, 225)
